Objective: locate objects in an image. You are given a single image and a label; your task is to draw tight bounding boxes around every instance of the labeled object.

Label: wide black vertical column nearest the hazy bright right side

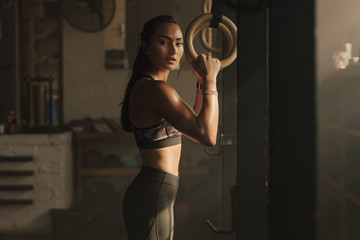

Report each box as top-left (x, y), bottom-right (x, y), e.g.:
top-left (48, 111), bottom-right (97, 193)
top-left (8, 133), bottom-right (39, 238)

top-left (269, 0), bottom-right (316, 240)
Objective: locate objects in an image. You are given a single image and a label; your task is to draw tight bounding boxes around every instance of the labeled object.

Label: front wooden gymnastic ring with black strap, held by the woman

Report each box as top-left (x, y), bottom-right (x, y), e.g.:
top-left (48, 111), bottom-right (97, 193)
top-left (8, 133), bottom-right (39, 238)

top-left (185, 13), bottom-right (237, 69)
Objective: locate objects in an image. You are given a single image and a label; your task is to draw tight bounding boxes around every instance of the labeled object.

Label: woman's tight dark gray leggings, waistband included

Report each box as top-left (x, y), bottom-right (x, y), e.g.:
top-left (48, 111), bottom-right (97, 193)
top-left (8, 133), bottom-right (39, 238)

top-left (123, 167), bottom-right (179, 240)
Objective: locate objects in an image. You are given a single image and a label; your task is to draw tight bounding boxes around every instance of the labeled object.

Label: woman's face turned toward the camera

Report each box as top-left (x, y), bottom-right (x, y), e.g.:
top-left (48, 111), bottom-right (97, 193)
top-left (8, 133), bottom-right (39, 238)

top-left (143, 23), bottom-right (184, 71)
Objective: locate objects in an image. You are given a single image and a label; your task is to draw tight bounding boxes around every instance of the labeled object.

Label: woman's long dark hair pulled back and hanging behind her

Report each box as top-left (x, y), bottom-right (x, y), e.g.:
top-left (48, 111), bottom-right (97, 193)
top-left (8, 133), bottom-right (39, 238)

top-left (121, 15), bottom-right (178, 132)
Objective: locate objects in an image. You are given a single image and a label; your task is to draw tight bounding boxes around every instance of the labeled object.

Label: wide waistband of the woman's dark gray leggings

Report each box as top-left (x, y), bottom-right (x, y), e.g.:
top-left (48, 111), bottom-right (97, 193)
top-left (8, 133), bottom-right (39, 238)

top-left (138, 166), bottom-right (179, 187)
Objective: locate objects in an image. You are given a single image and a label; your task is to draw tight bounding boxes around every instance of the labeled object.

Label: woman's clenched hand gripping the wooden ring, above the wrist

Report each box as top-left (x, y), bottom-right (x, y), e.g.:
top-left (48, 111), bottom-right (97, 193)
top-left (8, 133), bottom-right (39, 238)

top-left (192, 54), bottom-right (220, 83)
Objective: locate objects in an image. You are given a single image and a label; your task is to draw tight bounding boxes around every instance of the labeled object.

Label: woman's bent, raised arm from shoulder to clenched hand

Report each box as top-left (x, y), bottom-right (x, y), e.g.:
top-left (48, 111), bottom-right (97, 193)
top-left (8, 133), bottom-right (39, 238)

top-left (147, 55), bottom-right (220, 146)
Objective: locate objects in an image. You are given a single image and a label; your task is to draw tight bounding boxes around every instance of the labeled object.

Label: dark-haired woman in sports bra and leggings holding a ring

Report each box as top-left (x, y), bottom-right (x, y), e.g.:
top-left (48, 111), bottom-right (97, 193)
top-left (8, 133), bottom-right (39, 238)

top-left (121, 16), bottom-right (220, 240)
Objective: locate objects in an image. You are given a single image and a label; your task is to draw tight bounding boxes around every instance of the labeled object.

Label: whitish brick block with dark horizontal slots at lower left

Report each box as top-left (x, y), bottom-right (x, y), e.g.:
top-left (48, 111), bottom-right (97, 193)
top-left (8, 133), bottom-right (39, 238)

top-left (0, 132), bottom-right (73, 234)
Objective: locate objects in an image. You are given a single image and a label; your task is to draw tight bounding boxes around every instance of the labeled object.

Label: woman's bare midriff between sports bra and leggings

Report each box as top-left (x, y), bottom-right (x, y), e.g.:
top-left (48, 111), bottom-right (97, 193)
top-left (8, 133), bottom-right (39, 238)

top-left (139, 144), bottom-right (181, 176)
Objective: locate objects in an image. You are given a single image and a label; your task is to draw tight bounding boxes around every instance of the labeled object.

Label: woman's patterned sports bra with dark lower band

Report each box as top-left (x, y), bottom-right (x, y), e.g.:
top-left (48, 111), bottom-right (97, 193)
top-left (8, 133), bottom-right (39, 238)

top-left (132, 75), bottom-right (182, 149)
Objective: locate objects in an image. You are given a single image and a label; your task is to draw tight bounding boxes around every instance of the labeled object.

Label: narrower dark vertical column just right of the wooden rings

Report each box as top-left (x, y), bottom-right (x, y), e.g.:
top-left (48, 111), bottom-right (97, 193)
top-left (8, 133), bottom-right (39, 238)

top-left (233, 4), bottom-right (268, 240)
